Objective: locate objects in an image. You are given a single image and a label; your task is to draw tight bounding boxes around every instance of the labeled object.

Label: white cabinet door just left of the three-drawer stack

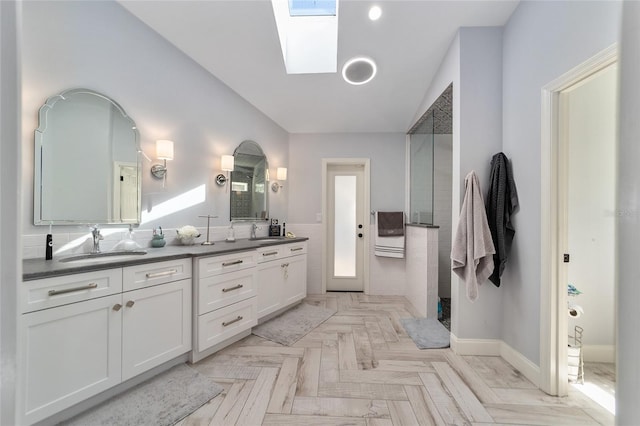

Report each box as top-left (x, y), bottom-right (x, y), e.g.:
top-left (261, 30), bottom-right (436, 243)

top-left (122, 280), bottom-right (191, 381)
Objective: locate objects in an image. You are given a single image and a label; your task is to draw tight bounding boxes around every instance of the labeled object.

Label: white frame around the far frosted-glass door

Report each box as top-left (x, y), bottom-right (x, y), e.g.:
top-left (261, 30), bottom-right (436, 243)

top-left (321, 158), bottom-right (371, 294)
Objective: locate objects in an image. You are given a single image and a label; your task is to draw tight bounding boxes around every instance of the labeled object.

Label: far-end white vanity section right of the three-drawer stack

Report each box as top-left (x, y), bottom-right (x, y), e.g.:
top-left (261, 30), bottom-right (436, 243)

top-left (257, 241), bottom-right (307, 319)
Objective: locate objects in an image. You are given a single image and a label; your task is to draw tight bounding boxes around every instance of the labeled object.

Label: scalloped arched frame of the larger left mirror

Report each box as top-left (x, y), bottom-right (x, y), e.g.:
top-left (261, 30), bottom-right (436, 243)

top-left (33, 88), bottom-right (142, 225)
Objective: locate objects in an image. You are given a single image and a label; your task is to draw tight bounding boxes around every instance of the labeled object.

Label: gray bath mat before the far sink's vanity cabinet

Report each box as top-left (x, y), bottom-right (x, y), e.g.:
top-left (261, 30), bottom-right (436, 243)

top-left (251, 303), bottom-right (336, 346)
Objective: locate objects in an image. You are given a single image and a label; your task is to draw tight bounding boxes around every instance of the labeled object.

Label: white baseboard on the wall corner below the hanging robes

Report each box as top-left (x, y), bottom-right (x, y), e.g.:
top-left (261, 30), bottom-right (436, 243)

top-left (450, 333), bottom-right (540, 386)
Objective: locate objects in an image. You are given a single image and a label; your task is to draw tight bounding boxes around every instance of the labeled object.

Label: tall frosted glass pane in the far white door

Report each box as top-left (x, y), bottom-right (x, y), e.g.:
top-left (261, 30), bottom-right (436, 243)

top-left (333, 176), bottom-right (357, 277)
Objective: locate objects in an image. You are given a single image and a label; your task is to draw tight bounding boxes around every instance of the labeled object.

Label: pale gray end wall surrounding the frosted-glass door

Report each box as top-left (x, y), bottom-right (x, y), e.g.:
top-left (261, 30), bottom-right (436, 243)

top-left (285, 133), bottom-right (406, 295)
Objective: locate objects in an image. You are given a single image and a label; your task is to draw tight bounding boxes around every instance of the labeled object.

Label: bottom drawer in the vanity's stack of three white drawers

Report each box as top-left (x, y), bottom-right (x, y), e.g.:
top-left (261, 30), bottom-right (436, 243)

top-left (198, 297), bottom-right (258, 352)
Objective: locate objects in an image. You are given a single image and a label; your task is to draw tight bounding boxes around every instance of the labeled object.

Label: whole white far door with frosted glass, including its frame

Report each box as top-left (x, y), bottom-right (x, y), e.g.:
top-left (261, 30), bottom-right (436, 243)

top-left (322, 158), bottom-right (370, 294)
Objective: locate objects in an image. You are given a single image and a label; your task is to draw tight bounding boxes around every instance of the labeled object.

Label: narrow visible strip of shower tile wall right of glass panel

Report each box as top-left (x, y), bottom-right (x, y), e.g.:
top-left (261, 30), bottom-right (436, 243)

top-left (433, 134), bottom-right (453, 297)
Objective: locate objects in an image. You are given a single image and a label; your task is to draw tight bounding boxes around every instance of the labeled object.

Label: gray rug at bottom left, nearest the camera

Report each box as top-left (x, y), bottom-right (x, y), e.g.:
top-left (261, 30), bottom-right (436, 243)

top-left (63, 364), bottom-right (223, 426)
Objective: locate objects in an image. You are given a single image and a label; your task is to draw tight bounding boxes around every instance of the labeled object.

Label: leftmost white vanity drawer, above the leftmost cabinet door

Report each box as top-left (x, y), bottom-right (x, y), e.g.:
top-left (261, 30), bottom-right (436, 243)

top-left (20, 268), bottom-right (122, 313)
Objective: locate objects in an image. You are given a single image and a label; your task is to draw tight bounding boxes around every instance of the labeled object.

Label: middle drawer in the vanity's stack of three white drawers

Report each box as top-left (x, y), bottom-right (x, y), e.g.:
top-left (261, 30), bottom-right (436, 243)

top-left (198, 268), bottom-right (257, 314)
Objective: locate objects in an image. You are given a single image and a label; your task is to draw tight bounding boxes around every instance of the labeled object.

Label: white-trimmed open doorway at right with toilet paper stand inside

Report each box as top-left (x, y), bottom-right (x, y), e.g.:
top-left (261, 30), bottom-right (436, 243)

top-left (540, 45), bottom-right (617, 404)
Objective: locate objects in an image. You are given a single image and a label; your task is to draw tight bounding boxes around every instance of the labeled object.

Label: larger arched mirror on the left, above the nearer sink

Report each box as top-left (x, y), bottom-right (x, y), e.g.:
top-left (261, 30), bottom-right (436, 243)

top-left (33, 89), bottom-right (141, 225)
